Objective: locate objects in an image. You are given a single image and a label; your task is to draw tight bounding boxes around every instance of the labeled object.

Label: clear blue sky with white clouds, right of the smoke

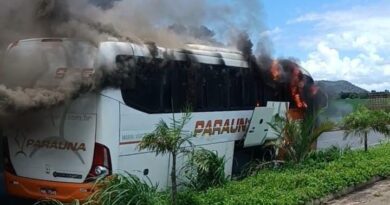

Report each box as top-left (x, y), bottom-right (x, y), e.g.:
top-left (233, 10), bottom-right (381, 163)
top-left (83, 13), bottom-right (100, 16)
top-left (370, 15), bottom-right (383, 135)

top-left (258, 0), bottom-right (390, 91)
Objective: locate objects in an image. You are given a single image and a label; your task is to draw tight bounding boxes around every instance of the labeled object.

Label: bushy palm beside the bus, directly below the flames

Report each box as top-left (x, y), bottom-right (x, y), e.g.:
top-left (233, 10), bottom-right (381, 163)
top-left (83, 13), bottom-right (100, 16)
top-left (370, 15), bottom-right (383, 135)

top-left (270, 113), bottom-right (334, 163)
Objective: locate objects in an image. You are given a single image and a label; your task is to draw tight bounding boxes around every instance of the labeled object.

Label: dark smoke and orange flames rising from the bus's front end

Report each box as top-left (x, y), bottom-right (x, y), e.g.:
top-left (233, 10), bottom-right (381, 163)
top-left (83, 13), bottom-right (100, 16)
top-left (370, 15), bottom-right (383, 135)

top-left (231, 29), bottom-right (317, 109)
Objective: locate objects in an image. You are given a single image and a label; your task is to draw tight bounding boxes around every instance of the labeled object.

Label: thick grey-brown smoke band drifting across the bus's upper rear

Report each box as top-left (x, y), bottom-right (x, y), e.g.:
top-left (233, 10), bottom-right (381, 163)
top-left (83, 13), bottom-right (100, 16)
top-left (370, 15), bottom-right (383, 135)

top-left (0, 64), bottom-right (97, 118)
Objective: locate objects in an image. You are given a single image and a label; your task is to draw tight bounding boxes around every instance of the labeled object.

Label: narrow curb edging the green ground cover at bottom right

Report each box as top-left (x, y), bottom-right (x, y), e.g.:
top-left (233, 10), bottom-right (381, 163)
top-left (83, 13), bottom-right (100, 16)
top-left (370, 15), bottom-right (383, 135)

top-left (305, 176), bottom-right (387, 205)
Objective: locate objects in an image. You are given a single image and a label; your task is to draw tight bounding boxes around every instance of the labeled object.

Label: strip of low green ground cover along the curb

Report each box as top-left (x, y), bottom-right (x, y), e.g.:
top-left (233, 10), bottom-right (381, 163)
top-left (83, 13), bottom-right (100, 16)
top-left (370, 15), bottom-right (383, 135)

top-left (193, 144), bottom-right (390, 205)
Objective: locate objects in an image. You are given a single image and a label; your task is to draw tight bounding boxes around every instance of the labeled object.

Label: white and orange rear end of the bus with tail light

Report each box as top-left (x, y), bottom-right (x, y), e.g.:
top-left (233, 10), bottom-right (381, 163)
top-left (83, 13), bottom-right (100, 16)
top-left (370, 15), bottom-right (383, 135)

top-left (0, 39), bottom-right (112, 202)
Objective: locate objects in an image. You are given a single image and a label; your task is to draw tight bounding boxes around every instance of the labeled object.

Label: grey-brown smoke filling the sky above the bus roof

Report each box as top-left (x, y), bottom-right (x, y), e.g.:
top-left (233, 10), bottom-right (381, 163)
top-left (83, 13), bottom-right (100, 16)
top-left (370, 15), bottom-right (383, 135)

top-left (0, 0), bottom-right (270, 55)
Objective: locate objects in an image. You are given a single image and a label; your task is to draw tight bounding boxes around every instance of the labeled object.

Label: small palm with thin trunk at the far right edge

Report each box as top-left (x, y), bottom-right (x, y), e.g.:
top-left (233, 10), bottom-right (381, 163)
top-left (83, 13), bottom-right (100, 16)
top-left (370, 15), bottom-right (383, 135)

top-left (342, 106), bottom-right (390, 151)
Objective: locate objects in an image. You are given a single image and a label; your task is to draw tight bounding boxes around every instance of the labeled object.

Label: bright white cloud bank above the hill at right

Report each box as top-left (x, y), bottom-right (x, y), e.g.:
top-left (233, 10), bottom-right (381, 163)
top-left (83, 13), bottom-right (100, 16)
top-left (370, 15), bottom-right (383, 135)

top-left (287, 4), bottom-right (390, 90)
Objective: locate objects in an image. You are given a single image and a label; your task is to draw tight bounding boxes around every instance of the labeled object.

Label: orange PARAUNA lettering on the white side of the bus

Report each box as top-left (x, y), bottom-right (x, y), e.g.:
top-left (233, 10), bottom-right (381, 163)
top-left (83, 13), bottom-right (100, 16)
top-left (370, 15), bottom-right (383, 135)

top-left (194, 118), bottom-right (250, 136)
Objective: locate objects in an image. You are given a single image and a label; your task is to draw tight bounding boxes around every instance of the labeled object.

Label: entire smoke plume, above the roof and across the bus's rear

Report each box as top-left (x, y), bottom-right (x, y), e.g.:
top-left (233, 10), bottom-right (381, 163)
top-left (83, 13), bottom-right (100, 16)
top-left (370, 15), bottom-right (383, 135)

top-left (0, 0), bottom-right (320, 116)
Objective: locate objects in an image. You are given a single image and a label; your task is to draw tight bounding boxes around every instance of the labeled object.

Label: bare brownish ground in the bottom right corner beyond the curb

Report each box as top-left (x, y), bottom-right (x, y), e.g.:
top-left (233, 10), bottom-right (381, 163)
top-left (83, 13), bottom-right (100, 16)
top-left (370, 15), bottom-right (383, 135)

top-left (327, 180), bottom-right (390, 205)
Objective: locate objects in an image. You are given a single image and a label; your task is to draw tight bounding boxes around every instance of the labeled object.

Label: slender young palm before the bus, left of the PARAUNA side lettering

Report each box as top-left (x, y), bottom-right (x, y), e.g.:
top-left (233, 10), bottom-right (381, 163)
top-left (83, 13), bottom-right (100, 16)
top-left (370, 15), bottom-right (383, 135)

top-left (138, 112), bottom-right (192, 205)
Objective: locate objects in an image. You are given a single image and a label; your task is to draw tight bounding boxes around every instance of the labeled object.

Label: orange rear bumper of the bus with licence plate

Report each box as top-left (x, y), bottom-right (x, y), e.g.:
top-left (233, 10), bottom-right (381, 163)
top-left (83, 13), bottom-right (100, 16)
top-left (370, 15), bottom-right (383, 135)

top-left (4, 171), bottom-right (93, 202)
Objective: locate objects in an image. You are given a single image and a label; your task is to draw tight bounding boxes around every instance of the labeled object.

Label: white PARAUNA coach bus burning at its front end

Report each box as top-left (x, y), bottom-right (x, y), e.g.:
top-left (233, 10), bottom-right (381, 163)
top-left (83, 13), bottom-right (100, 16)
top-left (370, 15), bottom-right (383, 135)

top-left (1, 38), bottom-right (318, 201)
